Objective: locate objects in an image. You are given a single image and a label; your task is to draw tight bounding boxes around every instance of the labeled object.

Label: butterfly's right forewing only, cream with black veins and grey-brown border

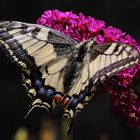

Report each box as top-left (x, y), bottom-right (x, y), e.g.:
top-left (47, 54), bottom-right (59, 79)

top-left (89, 43), bottom-right (139, 82)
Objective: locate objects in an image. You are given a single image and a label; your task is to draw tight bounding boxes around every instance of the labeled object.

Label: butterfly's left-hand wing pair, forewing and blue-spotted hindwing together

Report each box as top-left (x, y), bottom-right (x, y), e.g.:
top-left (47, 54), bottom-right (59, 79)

top-left (0, 21), bottom-right (77, 112)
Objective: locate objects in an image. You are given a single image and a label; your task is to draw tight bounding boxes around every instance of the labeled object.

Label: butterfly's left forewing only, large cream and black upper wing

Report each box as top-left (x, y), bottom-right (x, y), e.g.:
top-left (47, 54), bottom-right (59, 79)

top-left (0, 21), bottom-right (76, 69)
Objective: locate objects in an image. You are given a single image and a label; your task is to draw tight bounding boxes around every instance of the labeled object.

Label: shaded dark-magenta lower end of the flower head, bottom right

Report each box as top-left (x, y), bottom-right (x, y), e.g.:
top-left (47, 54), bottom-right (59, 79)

top-left (111, 90), bottom-right (140, 127)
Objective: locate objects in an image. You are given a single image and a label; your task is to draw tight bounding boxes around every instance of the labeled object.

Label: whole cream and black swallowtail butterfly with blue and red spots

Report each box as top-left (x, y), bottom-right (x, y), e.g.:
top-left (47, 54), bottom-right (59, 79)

top-left (0, 21), bottom-right (140, 132)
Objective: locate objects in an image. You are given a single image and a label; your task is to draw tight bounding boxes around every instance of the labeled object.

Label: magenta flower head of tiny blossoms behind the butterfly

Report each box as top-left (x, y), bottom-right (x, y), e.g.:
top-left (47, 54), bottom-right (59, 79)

top-left (37, 10), bottom-right (140, 127)
